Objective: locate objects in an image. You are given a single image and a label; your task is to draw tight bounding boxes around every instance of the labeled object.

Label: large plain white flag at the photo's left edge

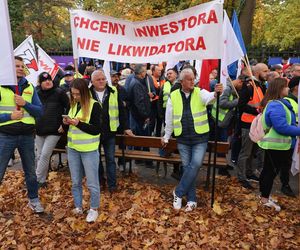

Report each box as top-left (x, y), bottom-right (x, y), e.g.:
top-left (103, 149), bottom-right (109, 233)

top-left (0, 0), bottom-right (17, 85)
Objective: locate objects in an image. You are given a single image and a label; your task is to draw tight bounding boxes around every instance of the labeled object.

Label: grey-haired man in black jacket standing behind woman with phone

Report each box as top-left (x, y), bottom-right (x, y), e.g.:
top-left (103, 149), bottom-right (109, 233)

top-left (90, 70), bottom-right (133, 194)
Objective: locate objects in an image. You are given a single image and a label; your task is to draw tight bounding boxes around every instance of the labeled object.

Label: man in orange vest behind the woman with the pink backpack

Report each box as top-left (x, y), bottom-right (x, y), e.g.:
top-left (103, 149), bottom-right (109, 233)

top-left (237, 63), bottom-right (269, 189)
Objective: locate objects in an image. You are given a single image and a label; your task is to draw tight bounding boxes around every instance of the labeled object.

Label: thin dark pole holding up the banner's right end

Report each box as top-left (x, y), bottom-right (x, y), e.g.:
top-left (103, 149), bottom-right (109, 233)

top-left (210, 59), bottom-right (221, 208)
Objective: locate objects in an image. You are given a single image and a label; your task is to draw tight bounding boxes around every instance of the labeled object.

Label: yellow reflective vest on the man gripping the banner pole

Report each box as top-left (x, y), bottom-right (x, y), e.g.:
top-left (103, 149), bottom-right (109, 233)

top-left (171, 87), bottom-right (209, 136)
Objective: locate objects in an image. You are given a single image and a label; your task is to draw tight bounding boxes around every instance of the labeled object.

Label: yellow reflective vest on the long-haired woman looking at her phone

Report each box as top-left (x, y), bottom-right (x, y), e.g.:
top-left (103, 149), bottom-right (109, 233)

top-left (68, 99), bottom-right (100, 152)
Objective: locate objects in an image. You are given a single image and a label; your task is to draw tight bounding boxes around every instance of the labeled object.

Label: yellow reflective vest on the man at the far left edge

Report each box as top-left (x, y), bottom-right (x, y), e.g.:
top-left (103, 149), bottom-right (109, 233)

top-left (0, 83), bottom-right (35, 126)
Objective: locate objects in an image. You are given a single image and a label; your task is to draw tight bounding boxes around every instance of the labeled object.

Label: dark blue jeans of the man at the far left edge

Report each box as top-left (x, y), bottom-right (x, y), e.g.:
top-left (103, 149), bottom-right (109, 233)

top-left (0, 133), bottom-right (39, 202)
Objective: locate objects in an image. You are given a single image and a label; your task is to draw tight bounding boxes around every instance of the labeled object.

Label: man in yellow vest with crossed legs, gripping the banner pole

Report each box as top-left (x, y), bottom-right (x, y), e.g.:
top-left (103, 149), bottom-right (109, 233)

top-left (162, 68), bottom-right (223, 212)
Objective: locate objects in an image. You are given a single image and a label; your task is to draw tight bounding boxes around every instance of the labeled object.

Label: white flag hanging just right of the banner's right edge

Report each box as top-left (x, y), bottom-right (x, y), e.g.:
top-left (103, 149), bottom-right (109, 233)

top-left (220, 11), bottom-right (244, 86)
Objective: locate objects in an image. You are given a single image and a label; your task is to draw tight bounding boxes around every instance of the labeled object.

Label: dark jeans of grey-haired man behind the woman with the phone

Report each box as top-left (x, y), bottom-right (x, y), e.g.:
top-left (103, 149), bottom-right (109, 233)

top-left (99, 136), bottom-right (117, 191)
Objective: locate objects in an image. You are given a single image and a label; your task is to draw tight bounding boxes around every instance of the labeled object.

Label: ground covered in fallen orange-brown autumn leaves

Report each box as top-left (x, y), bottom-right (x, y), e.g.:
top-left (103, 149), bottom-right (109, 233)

top-left (0, 171), bottom-right (300, 250)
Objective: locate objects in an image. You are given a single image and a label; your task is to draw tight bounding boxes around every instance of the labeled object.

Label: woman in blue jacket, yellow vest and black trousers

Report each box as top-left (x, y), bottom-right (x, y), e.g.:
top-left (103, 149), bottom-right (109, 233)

top-left (258, 78), bottom-right (300, 211)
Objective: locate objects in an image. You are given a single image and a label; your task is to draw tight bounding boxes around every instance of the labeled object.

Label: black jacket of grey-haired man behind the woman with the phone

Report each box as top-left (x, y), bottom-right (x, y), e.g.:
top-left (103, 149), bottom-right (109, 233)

top-left (90, 85), bottom-right (129, 138)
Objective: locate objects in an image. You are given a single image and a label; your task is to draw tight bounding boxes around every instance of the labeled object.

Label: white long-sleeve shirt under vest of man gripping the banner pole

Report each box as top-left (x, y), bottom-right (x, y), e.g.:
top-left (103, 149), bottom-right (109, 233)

top-left (163, 89), bottom-right (215, 143)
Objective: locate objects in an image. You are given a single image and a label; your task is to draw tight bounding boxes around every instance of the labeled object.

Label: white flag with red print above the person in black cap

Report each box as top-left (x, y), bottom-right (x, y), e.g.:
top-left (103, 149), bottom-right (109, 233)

top-left (36, 44), bottom-right (59, 79)
